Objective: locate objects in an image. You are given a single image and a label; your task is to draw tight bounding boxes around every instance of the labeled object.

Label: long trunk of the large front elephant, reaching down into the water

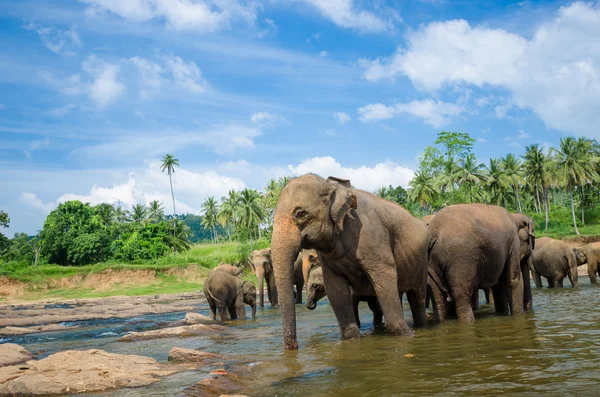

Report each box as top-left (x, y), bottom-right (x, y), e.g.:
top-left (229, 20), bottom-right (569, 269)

top-left (271, 214), bottom-right (301, 350)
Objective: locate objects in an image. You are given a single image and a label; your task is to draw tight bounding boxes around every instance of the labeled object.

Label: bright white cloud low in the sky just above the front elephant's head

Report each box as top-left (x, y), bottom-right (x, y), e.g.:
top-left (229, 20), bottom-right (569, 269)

top-left (288, 156), bottom-right (414, 191)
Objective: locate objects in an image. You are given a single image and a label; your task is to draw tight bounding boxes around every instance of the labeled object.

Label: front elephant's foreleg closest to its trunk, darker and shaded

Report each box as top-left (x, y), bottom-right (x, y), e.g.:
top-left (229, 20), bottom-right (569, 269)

top-left (322, 266), bottom-right (360, 339)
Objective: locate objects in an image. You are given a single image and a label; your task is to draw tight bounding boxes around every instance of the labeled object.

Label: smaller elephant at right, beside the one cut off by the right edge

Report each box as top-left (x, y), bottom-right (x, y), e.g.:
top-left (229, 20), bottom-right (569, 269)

top-left (532, 237), bottom-right (581, 288)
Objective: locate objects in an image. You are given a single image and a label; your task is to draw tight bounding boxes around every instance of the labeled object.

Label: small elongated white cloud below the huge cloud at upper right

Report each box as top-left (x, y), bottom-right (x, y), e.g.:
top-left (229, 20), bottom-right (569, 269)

top-left (358, 99), bottom-right (465, 128)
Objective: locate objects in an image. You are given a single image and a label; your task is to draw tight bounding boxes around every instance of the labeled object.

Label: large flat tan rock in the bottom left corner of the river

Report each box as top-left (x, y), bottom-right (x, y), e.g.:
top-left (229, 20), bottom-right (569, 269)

top-left (0, 349), bottom-right (184, 396)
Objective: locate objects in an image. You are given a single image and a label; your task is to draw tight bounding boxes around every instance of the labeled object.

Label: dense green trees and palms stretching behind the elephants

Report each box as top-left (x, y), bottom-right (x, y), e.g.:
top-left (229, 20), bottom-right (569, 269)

top-left (0, 132), bottom-right (600, 265)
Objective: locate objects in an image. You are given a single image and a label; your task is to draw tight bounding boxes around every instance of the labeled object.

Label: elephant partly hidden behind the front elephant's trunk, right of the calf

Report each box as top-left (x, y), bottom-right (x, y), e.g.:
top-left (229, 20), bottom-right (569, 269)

top-left (250, 248), bottom-right (304, 309)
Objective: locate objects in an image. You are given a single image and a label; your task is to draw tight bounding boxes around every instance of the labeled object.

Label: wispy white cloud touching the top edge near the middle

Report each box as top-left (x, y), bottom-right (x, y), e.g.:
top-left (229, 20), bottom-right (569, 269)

top-left (301, 0), bottom-right (392, 32)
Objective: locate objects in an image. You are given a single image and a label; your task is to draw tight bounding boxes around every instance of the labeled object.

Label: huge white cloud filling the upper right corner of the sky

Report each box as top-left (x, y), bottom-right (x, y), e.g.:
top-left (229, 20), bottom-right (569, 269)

top-left (361, 2), bottom-right (600, 137)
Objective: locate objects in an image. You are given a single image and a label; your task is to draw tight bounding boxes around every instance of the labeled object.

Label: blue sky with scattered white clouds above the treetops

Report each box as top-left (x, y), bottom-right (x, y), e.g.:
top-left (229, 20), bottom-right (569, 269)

top-left (0, 0), bottom-right (600, 235)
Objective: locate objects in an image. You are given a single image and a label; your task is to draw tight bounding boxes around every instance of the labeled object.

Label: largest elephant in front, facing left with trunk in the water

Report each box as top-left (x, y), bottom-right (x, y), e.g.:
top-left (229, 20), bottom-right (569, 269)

top-left (271, 174), bottom-right (427, 349)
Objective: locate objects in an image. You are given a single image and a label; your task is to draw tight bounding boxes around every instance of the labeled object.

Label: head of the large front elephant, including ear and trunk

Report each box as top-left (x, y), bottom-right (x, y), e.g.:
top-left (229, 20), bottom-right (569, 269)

top-left (271, 174), bottom-right (357, 349)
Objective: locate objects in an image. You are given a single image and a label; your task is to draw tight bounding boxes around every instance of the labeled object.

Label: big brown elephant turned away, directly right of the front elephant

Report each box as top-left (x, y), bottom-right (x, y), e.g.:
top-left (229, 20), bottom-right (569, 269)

top-left (427, 204), bottom-right (535, 322)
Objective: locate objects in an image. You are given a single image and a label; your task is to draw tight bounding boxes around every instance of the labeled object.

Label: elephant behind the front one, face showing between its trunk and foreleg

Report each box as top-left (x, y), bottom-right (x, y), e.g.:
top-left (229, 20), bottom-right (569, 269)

top-left (302, 250), bottom-right (383, 327)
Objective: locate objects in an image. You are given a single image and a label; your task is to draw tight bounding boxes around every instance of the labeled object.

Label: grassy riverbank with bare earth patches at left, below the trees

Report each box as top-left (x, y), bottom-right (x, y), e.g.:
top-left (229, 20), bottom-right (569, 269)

top-left (0, 240), bottom-right (270, 300)
